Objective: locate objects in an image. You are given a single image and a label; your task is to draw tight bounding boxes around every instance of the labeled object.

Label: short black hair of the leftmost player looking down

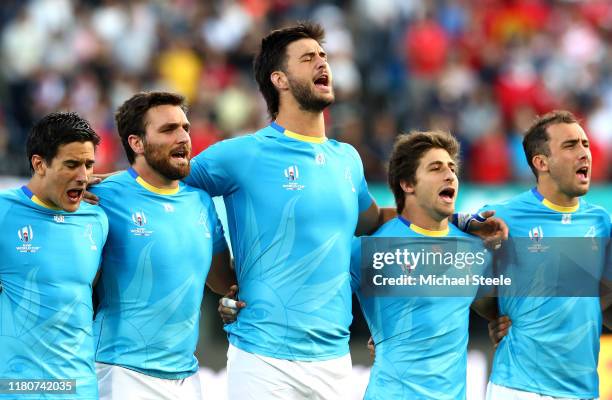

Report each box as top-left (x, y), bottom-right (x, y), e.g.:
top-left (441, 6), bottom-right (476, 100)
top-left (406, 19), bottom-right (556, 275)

top-left (26, 112), bottom-right (100, 172)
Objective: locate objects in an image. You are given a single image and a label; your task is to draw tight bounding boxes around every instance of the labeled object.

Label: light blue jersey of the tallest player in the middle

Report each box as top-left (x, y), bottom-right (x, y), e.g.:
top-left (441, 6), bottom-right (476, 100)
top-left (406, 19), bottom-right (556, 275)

top-left (186, 123), bottom-right (372, 361)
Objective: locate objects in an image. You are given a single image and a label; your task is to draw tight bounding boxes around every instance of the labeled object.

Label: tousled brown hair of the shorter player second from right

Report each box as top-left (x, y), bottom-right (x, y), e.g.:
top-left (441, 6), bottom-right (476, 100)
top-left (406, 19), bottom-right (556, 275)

top-left (388, 131), bottom-right (460, 214)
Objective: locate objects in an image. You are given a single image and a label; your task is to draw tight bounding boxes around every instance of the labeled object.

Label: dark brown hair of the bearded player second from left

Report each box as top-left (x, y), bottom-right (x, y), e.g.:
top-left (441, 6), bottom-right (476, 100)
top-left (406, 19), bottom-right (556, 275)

top-left (115, 92), bottom-right (187, 164)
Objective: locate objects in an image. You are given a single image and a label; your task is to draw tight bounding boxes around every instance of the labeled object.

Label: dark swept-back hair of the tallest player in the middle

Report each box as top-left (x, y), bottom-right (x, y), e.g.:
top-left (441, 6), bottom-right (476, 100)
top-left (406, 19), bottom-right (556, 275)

top-left (253, 22), bottom-right (325, 119)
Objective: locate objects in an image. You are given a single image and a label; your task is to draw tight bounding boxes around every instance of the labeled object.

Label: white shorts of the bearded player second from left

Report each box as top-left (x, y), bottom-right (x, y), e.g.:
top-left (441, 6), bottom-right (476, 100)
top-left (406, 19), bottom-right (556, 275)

top-left (96, 363), bottom-right (202, 400)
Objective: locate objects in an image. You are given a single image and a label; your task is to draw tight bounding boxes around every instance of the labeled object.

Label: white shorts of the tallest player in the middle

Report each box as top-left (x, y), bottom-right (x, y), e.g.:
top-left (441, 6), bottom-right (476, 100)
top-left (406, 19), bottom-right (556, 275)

top-left (227, 344), bottom-right (352, 400)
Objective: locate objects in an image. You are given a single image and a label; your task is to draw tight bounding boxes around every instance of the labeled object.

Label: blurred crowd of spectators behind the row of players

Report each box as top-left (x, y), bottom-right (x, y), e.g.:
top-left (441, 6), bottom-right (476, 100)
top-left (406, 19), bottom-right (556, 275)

top-left (0, 0), bottom-right (612, 183)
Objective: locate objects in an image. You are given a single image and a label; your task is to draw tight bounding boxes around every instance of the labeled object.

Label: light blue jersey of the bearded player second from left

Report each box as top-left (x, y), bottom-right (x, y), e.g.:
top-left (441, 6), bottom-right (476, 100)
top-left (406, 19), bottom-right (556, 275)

top-left (93, 168), bottom-right (226, 379)
